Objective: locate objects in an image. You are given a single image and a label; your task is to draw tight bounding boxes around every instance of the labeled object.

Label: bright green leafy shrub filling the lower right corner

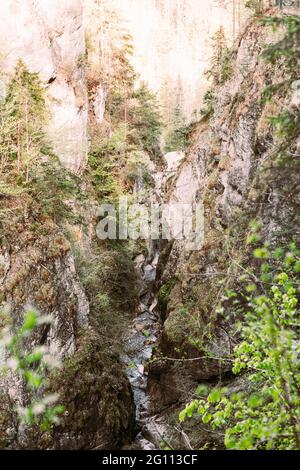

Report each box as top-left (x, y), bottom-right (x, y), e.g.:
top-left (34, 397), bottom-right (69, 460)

top-left (180, 243), bottom-right (300, 450)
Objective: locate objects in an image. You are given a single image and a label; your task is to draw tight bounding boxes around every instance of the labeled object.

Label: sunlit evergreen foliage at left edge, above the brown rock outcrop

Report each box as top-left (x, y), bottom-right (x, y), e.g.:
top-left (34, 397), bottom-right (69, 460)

top-left (0, 61), bottom-right (77, 221)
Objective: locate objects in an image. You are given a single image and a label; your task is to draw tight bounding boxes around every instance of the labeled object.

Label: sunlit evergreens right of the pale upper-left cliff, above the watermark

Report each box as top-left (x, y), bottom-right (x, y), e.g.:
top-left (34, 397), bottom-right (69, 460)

top-left (88, 27), bottom-right (162, 201)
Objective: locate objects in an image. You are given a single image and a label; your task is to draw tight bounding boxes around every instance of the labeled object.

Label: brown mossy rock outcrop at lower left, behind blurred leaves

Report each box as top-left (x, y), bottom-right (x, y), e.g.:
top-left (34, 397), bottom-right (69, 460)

top-left (0, 204), bottom-right (134, 449)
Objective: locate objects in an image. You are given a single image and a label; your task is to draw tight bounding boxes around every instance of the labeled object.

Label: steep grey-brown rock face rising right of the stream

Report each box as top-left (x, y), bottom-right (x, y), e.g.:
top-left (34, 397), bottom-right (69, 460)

top-left (149, 14), bottom-right (300, 445)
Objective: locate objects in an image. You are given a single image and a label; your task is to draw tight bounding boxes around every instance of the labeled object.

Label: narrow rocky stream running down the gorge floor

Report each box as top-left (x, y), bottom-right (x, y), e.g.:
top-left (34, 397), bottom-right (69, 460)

top-left (122, 152), bottom-right (184, 450)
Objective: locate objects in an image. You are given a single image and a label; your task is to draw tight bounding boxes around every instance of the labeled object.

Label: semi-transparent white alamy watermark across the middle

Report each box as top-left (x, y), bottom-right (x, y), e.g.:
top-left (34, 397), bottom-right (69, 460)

top-left (96, 196), bottom-right (204, 251)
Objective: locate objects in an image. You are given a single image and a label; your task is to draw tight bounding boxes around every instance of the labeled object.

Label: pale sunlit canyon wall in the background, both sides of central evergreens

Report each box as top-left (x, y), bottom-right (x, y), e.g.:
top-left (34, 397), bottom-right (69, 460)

top-left (0, 0), bottom-right (247, 173)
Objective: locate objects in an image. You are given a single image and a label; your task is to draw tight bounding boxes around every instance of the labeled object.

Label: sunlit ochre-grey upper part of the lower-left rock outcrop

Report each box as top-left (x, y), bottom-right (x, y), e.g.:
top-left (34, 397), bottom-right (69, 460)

top-left (0, 224), bottom-right (89, 359)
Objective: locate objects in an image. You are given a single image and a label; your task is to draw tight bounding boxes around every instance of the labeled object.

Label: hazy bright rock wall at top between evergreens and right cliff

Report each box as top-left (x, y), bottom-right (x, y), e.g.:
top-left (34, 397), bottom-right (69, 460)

top-left (113, 0), bottom-right (248, 121)
